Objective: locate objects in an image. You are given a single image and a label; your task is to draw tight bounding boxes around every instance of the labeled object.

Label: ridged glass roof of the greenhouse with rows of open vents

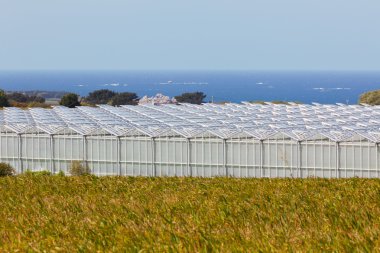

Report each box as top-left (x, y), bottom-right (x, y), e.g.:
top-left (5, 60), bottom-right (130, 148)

top-left (0, 103), bottom-right (380, 143)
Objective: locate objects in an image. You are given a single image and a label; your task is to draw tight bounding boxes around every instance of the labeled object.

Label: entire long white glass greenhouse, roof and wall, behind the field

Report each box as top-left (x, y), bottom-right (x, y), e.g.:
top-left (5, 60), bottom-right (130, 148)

top-left (0, 102), bottom-right (380, 178)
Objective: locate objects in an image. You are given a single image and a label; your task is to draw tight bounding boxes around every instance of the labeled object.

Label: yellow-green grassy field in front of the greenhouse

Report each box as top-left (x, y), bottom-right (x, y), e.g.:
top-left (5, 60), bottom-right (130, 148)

top-left (0, 175), bottom-right (380, 252)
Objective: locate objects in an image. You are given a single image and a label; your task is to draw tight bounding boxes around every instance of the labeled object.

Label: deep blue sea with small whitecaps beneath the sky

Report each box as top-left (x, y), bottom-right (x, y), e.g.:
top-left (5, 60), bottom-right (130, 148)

top-left (0, 71), bottom-right (380, 104)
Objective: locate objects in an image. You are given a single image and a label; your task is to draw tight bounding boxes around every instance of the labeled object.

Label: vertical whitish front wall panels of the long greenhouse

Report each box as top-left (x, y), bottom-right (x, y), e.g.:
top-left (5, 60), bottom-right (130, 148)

top-left (0, 132), bottom-right (380, 177)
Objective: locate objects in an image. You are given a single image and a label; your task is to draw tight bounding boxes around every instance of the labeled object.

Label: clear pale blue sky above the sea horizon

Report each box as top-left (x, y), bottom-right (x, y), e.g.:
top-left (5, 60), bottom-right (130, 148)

top-left (0, 0), bottom-right (380, 70)
